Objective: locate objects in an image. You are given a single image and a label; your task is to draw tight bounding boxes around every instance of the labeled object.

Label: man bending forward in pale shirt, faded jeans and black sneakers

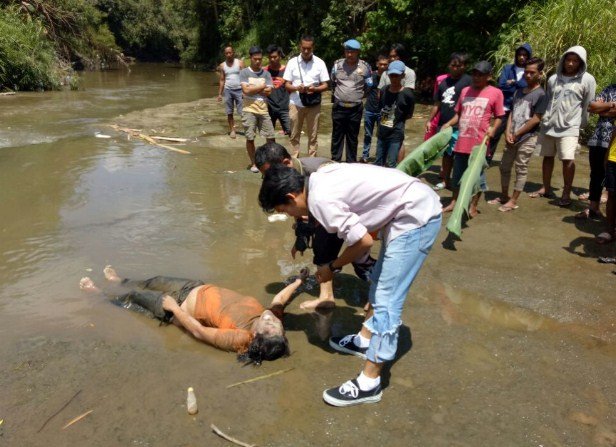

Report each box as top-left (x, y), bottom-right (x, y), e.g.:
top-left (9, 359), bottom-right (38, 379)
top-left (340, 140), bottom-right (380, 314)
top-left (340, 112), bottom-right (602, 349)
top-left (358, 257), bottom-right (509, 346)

top-left (259, 163), bottom-right (441, 407)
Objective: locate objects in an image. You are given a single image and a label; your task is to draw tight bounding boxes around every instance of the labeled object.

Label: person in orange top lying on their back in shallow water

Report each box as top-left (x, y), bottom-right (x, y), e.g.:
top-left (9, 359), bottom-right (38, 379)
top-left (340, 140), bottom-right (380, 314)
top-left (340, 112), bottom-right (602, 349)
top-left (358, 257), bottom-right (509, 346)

top-left (79, 266), bottom-right (308, 365)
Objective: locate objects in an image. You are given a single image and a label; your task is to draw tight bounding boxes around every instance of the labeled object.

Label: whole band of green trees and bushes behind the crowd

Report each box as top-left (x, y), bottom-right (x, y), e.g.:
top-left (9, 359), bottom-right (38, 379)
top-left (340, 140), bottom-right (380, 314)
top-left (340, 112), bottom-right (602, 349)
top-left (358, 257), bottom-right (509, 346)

top-left (0, 0), bottom-right (616, 89)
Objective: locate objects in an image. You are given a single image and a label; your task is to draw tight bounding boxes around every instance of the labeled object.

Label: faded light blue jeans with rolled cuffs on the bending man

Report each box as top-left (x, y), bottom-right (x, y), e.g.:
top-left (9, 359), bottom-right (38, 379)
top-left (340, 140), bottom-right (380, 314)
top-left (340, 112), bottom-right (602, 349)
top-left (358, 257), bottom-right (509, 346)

top-left (364, 216), bottom-right (441, 363)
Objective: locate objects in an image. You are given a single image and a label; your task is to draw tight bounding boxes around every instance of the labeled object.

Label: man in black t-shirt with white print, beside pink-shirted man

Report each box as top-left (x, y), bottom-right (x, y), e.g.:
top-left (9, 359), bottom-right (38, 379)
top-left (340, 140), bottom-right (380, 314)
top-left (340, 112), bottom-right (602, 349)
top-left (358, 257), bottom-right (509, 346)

top-left (426, 53), bottom-right (472, 191)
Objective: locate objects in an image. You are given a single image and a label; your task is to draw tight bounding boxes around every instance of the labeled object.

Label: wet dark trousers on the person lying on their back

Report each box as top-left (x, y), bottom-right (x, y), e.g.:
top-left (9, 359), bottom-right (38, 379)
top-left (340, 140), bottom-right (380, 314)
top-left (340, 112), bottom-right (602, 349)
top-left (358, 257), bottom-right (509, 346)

top-left (112, 276), bottom-right (205, 322)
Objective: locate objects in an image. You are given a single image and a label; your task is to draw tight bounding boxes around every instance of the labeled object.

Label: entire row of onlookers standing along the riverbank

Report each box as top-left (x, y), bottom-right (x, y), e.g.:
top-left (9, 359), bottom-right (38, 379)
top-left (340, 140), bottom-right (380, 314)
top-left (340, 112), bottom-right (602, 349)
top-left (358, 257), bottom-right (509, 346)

top-left (219, 35), bottom-right (616, 243)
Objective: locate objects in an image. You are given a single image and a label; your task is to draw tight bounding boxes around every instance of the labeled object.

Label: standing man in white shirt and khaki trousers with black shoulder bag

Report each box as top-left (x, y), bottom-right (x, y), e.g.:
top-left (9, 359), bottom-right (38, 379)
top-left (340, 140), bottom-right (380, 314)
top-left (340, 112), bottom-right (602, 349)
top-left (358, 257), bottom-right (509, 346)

top-left (283, 35), bottom-right (329, 157)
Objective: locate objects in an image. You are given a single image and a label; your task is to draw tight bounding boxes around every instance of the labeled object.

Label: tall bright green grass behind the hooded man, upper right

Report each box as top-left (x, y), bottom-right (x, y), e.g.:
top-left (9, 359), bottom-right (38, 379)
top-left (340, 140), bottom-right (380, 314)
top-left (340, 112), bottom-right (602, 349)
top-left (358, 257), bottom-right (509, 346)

top-left (492, 0), bottom-right (616, 89)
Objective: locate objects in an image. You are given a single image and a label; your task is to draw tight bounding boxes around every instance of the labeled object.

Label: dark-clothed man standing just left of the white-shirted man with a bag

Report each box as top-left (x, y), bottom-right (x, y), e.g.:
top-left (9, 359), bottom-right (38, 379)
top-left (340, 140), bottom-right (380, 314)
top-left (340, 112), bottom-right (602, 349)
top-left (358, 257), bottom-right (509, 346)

top-left (264, 45), bottom-right (291, 135)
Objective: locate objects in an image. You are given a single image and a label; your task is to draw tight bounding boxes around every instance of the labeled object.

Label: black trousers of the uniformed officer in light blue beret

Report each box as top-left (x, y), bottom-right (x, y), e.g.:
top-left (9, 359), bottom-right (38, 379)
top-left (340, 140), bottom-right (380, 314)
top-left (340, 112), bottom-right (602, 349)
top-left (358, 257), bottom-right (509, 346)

top-left (332, 103), bottom-right (364, 163)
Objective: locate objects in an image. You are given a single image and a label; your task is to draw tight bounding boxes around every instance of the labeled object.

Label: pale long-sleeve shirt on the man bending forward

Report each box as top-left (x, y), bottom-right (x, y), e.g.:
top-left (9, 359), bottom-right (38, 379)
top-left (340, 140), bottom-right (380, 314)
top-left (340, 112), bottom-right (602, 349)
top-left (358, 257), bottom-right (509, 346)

top-left (308, 163), bottom-right (441, 245)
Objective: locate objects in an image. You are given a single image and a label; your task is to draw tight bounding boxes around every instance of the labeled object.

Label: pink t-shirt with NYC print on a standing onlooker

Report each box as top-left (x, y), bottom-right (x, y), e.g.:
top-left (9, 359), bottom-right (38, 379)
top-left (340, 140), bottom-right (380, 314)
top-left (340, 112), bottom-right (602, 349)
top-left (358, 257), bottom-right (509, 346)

top-left (453, 85), bottom-right (505, 154)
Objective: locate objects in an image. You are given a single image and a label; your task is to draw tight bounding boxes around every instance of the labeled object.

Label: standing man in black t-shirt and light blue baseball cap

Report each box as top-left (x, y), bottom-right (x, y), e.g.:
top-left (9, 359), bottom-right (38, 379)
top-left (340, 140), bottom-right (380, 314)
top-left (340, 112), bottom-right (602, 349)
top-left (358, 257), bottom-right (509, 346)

top-left (374, 61), bottom-right (415, 168)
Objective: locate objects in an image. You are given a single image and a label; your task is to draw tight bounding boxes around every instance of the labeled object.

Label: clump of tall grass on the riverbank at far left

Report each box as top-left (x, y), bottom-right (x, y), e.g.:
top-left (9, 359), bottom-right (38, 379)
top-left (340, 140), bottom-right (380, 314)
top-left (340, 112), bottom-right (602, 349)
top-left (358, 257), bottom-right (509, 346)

top-left (0, 7), bottom-right (61, 90)
